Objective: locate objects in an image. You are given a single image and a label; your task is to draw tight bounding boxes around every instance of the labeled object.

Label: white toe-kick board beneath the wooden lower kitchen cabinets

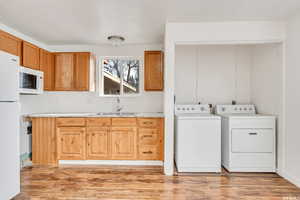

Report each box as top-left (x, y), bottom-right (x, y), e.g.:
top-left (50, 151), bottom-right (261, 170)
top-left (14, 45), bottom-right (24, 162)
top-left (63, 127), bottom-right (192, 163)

top-left (58, 160), bottom-right (163, 166)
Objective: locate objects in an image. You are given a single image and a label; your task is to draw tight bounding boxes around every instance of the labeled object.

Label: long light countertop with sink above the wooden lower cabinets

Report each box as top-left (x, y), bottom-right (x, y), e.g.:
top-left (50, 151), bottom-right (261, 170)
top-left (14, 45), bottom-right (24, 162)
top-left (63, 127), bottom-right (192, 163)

top-left (24, 112), bottom-right (164, 118)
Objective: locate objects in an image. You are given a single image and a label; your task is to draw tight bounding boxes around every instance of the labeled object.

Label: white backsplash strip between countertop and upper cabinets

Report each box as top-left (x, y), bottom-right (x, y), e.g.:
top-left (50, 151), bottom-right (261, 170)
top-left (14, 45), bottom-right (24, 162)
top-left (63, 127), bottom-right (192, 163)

top-left (20, 92), bottom-right (163, 114)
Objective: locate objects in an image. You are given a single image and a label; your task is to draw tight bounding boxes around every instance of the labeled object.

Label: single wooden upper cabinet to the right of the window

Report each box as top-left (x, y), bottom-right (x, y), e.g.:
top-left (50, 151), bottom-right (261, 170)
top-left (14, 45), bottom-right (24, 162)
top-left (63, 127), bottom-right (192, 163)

top-left (144, 51), bottom-right (164, 91)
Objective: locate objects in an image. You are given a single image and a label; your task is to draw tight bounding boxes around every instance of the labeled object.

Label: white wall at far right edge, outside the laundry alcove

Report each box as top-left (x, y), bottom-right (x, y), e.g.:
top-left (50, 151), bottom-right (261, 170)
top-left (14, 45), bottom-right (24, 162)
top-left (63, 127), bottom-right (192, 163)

top-left (284, 15), bottom-right (300, 187)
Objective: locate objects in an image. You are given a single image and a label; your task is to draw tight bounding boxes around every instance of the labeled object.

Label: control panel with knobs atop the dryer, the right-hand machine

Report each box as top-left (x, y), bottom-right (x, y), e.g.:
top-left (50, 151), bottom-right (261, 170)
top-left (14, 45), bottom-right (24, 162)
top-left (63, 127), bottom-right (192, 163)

top-left (216, 105), bottom-right (256, 114)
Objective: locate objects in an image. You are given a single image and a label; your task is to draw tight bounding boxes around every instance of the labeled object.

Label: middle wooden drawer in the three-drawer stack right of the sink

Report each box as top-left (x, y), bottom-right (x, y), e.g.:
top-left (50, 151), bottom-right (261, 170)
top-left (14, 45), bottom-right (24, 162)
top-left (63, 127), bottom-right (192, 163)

top-left (139, 128), bottom-right (159, 145)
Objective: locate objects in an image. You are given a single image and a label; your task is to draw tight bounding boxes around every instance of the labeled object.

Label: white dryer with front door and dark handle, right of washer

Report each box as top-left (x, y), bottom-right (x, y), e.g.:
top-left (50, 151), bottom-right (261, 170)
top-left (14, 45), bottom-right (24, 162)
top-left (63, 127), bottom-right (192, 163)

top-left (216, 105), bottom-right (276, 172)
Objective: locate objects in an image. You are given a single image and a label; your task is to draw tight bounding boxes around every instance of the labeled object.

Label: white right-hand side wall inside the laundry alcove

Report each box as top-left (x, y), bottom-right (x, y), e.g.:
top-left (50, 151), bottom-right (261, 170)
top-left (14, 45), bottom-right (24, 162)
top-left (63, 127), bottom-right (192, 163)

top-left (251, 44), bottom-right (284, 174)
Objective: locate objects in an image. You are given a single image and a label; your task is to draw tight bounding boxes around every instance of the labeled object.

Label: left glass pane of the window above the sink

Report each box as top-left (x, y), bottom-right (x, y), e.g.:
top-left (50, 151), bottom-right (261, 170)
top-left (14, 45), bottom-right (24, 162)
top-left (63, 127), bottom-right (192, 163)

top-left (103, 59), bottom-right (121, 95)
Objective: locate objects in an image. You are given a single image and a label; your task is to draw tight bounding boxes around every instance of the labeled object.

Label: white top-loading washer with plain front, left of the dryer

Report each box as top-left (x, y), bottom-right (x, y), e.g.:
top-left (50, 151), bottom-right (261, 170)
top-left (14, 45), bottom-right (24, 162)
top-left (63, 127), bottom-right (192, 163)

top-left (175, 104), bottom-right (221, 172)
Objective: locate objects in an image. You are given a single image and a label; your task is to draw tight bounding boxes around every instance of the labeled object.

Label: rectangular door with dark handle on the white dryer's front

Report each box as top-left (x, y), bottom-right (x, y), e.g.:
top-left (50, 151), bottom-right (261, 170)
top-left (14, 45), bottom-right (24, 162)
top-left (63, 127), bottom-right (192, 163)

top-left (231, 129), bottom-right (275, 153)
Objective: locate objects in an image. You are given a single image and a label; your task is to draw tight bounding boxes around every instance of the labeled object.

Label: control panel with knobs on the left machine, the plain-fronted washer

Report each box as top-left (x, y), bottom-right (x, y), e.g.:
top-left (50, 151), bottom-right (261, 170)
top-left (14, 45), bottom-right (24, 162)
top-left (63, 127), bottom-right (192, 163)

top-left (175, 104), bottom-right (210, 114)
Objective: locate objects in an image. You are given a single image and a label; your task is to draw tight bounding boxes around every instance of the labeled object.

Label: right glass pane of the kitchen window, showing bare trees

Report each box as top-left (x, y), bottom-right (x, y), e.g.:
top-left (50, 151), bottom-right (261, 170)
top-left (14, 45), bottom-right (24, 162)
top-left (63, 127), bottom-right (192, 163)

top-left (122, 60), bottom-right (140, 94)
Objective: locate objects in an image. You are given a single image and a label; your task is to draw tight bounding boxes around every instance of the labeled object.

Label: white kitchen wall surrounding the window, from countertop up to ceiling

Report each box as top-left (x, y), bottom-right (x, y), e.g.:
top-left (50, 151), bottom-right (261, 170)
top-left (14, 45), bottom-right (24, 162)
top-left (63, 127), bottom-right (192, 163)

top-left (21, 44), bottom-right (163, 114)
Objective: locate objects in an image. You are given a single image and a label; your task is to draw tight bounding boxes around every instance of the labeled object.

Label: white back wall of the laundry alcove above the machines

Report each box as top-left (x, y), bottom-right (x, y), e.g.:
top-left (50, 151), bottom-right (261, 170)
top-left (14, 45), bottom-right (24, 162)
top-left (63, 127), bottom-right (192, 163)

top-left (175, 45), bottom-right (252, 105)
